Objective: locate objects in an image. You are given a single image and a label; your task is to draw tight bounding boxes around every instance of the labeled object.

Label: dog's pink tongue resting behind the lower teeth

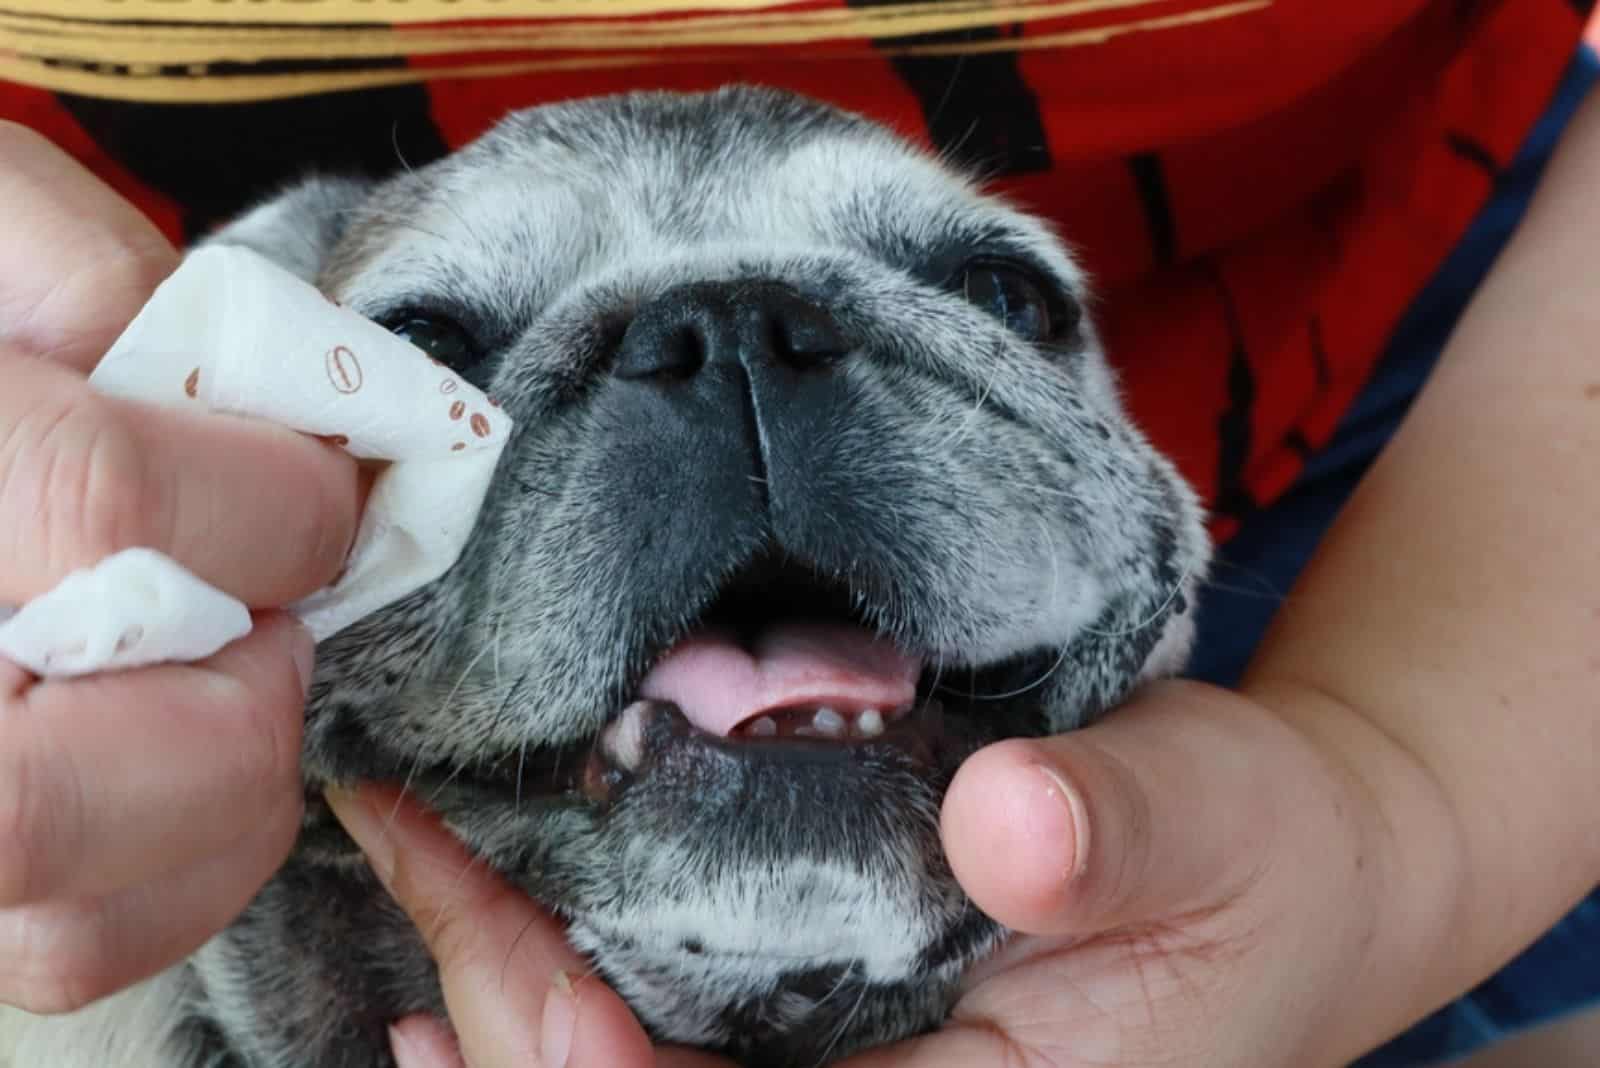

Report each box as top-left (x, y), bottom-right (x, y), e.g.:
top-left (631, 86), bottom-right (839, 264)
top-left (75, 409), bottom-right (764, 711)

top-left (638, 624), bottom-right (922, 735)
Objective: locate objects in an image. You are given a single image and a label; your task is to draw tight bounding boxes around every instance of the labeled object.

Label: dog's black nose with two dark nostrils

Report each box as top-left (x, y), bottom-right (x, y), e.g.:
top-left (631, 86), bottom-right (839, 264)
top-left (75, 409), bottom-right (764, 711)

top-left (613, 283), bottom-right (850, 379)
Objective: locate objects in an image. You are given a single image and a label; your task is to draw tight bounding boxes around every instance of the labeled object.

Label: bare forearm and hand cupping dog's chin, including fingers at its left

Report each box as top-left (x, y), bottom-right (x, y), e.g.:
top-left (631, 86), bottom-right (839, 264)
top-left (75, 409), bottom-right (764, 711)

top-left (334, 75), bottom-right (1600, 1068)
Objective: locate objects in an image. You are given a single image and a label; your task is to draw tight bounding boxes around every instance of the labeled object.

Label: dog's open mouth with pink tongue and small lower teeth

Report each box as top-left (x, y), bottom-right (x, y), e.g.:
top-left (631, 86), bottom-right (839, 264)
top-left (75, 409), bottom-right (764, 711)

top-left (573, 555), bottom-right (1032, 803)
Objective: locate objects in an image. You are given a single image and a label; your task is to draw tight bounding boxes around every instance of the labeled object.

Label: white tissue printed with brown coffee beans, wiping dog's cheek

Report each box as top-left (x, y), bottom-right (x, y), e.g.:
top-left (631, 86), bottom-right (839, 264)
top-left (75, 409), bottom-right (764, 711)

top-left (0, 245), bottom-right (512, 676)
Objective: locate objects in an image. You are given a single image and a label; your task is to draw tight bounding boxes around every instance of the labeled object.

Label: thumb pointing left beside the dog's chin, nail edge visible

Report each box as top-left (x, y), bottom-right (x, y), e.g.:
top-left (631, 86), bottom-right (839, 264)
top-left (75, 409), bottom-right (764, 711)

top-left (942, 683), bottom-right (1317, 935)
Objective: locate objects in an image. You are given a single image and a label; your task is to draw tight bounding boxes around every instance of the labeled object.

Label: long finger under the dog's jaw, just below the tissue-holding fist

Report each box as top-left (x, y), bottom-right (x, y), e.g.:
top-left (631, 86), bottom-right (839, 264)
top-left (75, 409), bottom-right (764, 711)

top-left (328, 787), bottom-right (653, 1068)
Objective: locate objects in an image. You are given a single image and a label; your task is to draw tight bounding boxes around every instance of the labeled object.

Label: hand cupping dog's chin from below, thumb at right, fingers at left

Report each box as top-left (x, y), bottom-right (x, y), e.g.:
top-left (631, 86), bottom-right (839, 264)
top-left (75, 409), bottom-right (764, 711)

top-left (324, 683), bottom-right (1443, 1068)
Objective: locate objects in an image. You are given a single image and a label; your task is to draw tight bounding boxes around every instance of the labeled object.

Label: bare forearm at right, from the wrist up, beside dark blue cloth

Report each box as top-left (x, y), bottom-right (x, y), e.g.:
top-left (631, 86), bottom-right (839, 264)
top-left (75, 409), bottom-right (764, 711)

top-left (1243, 79), bottom-right (1600, 1055)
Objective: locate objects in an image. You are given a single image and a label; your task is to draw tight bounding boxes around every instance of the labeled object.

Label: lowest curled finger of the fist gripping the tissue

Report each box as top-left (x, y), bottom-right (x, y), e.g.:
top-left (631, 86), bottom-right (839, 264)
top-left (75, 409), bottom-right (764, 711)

top-left (0, 798), bottom-right (301, 1014)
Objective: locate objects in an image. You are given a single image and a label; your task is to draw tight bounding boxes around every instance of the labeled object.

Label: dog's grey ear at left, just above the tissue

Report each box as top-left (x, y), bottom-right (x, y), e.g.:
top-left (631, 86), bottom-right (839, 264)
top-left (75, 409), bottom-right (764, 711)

top-left (198, 176), bottom-right (374, 285)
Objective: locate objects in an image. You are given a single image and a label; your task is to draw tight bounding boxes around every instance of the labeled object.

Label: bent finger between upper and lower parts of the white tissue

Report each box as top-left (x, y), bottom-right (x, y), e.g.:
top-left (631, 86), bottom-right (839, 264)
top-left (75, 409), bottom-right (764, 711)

top-left (0, 350), bottom-right (360, 608)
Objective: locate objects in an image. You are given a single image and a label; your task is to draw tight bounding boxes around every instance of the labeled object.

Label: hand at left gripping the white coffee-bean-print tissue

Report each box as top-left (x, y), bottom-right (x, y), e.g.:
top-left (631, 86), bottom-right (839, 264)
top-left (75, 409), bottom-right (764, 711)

top-left (0, 123), bottom-right (360, 1012)
